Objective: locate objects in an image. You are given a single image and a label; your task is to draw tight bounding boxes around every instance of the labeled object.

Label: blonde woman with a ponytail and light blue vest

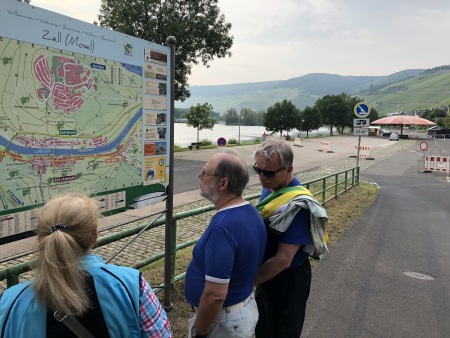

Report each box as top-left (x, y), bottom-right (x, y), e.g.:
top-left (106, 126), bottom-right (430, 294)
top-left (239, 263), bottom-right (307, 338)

top-left (0, 193), bottom-right (172, 338)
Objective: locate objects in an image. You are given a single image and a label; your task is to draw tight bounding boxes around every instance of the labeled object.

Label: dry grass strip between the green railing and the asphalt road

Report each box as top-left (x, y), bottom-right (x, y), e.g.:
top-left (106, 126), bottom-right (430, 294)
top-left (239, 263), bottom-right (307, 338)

top-left (142, 182), bottom-right (378, 337)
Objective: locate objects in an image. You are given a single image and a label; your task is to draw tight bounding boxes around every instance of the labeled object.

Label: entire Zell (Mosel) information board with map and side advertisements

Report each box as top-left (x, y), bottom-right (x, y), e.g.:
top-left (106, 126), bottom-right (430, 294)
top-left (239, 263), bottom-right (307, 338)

top-left (0, 0), bottom-right (170, 237)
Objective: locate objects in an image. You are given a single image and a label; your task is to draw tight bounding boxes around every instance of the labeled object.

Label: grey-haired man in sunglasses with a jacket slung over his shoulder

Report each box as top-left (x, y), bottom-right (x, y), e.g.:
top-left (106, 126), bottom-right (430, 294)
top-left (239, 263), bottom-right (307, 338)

top-left (253, 139), bottom-right (317, 338)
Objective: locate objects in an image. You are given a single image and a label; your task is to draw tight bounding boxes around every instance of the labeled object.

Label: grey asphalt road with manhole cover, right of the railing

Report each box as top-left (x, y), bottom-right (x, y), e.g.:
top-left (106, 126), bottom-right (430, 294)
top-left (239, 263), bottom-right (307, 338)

top-left (302, 141), bottom-right (450, 338)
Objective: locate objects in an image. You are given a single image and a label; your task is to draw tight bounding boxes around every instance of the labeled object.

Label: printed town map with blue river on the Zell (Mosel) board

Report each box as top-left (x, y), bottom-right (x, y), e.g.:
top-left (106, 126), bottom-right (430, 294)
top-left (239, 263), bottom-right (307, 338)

top-left (0, 38), bottom-right (143, 211)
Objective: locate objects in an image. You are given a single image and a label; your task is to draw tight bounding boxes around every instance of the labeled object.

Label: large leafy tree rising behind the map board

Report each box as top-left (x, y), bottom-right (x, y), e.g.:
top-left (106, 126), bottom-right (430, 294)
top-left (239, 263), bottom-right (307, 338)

top-left (98, 0), bottom-right (233, 101)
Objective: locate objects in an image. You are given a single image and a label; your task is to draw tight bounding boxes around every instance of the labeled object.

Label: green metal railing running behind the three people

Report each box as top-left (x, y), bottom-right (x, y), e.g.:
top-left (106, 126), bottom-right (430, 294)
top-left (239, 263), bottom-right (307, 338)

top-left (0, 167), bottom-right (359, 304)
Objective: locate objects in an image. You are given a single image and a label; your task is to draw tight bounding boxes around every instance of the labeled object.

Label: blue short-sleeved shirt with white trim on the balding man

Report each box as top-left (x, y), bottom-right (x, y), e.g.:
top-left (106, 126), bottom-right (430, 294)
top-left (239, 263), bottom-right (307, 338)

top-left (185, 202), bottom-right (267, 307)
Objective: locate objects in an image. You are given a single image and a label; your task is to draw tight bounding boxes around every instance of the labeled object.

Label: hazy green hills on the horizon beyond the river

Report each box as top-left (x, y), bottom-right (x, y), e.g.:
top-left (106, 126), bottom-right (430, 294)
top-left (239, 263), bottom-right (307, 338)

top-left (175, 66), bottom-right (442, 115)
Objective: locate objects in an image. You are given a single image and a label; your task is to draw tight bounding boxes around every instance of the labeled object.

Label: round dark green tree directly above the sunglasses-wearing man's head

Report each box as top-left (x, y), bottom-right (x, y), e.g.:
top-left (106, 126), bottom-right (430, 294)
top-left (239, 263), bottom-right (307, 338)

top-left (264, 100), bottom-right (299, 137)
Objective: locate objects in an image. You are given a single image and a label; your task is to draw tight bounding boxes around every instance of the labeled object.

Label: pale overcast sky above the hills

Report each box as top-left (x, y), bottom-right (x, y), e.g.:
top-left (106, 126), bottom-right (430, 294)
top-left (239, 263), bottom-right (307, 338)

top-left (31, 0), bottom-right (450, 86)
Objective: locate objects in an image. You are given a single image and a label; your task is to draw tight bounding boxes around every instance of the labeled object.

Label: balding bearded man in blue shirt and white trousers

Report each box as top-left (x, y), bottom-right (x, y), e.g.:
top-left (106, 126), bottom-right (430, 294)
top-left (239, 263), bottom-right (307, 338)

top-left (185, 153), bottom-right (267, 338)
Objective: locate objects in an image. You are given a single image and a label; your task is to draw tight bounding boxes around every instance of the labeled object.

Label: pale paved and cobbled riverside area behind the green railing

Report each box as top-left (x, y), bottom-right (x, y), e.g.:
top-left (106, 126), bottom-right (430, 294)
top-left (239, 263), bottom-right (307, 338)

top-left (0, 134), bottom-right (426, 290)
